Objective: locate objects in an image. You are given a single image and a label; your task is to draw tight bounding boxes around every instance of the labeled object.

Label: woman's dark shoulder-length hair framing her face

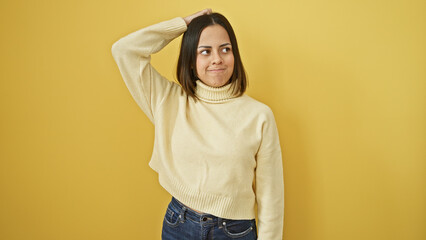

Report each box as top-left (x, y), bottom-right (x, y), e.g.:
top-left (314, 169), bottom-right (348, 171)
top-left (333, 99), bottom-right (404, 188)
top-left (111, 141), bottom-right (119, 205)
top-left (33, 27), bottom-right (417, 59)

top-left (176, 13), bottom-right (247, 98)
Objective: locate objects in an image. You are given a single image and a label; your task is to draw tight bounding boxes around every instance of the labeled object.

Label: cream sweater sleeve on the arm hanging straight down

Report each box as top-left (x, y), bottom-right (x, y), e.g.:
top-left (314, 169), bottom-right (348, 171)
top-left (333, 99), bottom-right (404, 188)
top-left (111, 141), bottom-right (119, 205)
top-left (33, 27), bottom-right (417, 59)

top-left (255, 111), bottom-right (284, 240)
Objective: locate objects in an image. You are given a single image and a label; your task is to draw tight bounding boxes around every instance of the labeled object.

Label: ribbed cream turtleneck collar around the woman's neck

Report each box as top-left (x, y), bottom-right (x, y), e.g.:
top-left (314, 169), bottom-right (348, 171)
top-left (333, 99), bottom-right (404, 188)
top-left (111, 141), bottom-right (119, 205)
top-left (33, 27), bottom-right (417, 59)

top-left (195, 80), bottom-right (238, 103)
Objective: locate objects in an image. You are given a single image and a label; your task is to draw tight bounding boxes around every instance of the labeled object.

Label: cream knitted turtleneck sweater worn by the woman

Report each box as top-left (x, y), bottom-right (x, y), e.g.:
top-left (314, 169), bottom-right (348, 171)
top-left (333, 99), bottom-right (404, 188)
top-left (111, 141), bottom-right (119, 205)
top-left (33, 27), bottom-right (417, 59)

top-left (112, 17), bottom-right (284, 240)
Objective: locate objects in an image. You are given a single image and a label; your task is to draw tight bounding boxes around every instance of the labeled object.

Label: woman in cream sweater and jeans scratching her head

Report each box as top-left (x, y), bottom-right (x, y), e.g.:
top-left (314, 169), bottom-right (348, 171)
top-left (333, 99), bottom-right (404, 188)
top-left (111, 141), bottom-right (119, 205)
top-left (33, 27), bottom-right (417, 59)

top-left (112, 9), bottom-right (284, 240)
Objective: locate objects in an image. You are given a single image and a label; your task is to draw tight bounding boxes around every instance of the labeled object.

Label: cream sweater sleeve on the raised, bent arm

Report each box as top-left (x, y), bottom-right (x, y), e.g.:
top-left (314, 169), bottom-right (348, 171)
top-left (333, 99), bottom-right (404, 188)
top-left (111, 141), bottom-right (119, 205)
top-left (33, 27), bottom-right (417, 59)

top-left (111, 17), bottom-right (187, 123)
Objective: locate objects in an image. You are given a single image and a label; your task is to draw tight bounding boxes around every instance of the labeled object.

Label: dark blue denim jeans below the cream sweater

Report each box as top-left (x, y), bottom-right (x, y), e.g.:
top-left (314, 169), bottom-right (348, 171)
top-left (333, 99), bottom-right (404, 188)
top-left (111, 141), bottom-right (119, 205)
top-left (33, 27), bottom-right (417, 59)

top-left (161, 197), bottom-right (257, 240)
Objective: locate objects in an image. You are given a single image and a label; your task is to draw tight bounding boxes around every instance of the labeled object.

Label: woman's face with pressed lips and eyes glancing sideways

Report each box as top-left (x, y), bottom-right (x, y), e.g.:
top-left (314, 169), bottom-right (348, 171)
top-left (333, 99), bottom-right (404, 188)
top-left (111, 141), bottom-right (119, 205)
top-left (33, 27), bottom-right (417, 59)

top-left (196, 24), bottom-right (234, 87)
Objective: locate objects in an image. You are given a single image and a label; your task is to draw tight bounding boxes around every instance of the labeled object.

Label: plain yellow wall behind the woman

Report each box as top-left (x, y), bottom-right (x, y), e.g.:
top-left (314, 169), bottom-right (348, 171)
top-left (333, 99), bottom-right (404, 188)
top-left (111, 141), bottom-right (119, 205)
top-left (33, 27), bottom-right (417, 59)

top-left (0, 0), bottom-right (426, 240)
